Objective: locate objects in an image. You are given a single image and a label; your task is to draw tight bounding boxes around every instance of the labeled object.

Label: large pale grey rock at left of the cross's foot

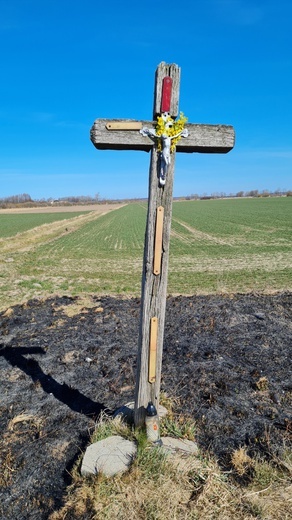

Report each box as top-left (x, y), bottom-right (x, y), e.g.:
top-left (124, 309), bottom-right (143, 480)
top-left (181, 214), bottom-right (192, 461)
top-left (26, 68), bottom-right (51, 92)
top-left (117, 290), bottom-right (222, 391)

top-left (81, 435), bottom-right (137, 477)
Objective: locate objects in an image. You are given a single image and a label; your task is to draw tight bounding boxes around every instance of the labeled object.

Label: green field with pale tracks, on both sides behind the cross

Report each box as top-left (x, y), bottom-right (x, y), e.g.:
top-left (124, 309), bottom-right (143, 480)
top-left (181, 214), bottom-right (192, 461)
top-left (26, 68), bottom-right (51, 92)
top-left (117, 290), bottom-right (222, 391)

top-left (0, 197), bottom-right (292, 309)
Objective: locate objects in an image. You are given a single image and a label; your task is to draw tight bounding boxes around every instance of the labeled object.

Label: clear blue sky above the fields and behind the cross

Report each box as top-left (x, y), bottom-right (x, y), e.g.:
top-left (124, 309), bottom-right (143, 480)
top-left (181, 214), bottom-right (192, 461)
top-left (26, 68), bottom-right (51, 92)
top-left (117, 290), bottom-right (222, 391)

top-left (0, 0), bottom-right (292, 198)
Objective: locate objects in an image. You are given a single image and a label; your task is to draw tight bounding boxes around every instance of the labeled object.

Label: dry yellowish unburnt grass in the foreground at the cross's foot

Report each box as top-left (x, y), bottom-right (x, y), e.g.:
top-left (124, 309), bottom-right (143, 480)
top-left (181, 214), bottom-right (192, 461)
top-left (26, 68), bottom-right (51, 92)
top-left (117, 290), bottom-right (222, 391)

top-left (49, 402), bottom-right (292, 520)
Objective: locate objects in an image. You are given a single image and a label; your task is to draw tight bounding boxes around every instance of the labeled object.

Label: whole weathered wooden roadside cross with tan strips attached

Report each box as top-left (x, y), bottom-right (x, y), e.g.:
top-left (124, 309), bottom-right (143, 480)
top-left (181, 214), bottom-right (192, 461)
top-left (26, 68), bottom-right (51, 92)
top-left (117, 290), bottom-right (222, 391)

top-left (90, 62), bottom-right (234, 426)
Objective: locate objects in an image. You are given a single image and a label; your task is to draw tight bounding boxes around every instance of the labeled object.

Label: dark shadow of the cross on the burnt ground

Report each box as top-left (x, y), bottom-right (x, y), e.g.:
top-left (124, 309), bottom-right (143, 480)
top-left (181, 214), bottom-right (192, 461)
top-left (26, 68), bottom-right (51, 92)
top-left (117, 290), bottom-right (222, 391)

top-left (0, 347), bottom-right (106, 419)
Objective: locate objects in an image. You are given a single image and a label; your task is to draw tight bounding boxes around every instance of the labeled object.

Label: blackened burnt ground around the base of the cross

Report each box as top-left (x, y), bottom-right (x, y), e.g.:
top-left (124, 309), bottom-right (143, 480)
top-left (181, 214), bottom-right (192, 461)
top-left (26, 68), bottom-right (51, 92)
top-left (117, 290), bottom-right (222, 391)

top-left (0, 292), bottom-right (292, 520)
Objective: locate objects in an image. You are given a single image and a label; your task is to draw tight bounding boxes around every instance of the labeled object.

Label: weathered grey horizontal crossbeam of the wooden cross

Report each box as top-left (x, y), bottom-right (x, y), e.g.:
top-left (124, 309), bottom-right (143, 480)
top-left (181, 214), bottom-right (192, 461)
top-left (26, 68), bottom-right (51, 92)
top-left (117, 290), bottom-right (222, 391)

top-left (90, 119), bottom-right (235, 153)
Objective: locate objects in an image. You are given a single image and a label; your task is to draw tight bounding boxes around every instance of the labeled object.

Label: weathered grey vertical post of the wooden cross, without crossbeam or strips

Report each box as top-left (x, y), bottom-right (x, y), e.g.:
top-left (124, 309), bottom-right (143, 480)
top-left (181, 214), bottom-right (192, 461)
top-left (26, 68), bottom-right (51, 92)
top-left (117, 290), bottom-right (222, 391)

top-left (134, 64), bottom-right (180, 427)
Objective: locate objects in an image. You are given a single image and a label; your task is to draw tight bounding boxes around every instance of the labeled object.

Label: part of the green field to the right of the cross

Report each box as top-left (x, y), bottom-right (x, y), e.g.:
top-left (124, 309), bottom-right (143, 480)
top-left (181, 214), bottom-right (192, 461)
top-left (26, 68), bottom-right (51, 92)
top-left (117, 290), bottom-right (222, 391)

top-left (169, 197), bottom-right (292, 293)
